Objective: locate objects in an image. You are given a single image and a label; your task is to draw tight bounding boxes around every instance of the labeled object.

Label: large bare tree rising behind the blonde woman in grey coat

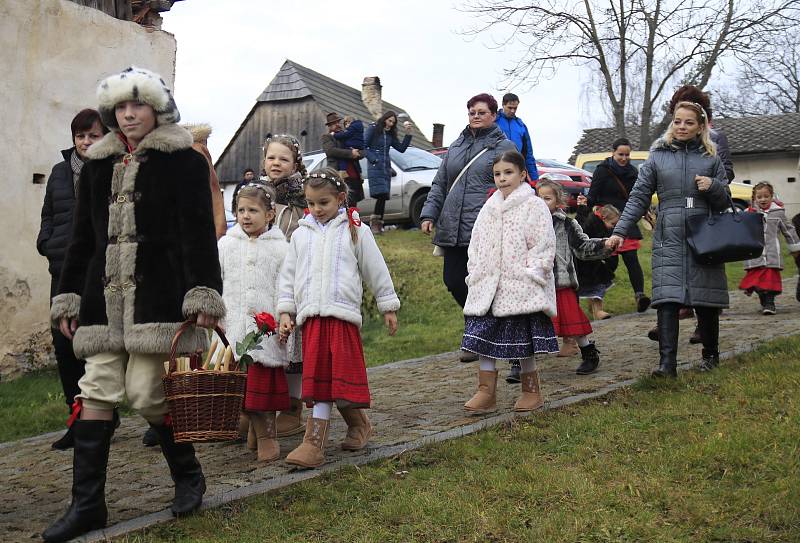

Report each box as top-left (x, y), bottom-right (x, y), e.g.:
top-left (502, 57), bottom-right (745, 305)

top-left (462, 0), bottom-right (800, 148)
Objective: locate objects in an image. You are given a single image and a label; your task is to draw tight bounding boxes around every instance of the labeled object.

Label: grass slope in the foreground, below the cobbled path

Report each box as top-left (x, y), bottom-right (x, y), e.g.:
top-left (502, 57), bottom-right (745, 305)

top-left (118, 337), bottom-right (800, 543)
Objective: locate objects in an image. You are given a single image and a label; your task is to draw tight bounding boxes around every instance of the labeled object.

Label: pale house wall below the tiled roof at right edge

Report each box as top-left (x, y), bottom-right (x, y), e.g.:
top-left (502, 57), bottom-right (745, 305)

top-left (733, 150), bottom-right (800, 217)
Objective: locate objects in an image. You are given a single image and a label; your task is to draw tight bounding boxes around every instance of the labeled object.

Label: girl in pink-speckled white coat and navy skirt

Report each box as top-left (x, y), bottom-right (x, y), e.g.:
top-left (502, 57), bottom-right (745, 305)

top-left (461, 151), bottom-right (558, 413)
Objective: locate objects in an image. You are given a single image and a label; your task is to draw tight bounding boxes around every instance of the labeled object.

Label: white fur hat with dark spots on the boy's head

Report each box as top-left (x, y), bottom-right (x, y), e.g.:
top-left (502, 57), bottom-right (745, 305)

top-left (97, 66), bottom-right (181, 129)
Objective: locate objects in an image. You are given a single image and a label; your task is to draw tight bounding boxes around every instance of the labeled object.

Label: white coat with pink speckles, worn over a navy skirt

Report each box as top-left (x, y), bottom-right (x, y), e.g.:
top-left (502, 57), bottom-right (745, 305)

top-left (464, 183), bottom-right (556, 317)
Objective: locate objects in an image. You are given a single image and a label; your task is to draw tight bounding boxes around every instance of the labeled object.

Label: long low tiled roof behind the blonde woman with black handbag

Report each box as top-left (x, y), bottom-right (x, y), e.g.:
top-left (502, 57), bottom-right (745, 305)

top-left (569, 113), bottom-right (800, 164)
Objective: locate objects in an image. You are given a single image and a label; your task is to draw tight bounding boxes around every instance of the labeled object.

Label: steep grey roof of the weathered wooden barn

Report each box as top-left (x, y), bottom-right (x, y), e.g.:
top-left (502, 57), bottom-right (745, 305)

top-left (258, 60), bottom-right (433, 149)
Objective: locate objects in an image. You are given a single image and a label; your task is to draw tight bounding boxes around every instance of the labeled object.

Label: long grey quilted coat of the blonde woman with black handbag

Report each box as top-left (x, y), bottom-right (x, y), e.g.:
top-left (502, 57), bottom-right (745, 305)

top-left (614, 139), bottom-right (728, 307)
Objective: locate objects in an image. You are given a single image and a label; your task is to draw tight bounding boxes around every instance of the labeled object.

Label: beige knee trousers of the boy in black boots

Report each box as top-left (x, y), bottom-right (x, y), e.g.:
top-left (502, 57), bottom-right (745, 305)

top-left (76, 352), bottom-right (169, 424)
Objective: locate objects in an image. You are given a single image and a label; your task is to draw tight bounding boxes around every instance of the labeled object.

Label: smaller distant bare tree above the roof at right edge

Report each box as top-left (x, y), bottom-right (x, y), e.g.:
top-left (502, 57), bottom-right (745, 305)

top-left (713, 33), bottom-right (800, 117)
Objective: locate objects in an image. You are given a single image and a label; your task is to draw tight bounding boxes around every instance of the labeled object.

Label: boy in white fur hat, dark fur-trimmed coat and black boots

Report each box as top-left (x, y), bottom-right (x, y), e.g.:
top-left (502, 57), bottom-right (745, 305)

top-left (42, 67), bottom-right (225, 541)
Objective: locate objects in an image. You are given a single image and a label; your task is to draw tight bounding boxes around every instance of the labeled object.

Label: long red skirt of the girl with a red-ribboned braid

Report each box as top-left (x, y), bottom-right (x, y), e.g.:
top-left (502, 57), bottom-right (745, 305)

top-left (303, 317), bottom-right (370, 407)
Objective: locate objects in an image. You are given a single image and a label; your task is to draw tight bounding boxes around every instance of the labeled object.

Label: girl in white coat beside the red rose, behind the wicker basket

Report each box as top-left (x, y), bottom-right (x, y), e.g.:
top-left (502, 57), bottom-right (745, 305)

top-left (218, 183), bottom-right (290, 462)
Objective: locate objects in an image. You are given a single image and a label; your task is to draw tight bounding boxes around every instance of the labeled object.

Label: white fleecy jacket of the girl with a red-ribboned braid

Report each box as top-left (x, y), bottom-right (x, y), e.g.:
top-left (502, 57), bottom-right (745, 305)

top-left (278, 213), bottom-right (400, 327)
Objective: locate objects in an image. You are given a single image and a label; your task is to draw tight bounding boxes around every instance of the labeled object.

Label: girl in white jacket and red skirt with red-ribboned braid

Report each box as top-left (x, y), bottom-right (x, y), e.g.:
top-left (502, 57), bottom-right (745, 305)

top-left (278, 168), bottom-right (400, 468)
